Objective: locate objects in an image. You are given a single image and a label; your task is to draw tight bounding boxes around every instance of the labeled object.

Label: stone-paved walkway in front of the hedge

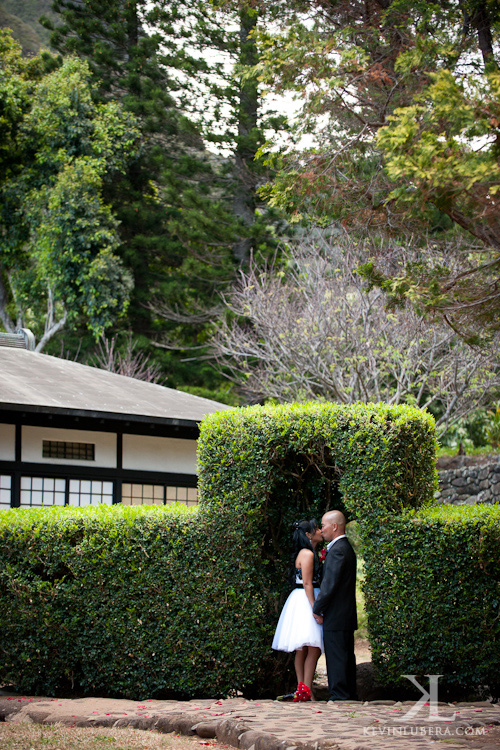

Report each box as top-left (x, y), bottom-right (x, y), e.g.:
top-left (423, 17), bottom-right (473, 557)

top-left (0, 695), bottom-right (500, 750)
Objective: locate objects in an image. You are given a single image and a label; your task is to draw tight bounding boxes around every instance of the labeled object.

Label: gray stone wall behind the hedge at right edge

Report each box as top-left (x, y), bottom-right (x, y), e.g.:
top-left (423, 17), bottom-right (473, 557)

top-left (435, 459), bottom-right (500, 505)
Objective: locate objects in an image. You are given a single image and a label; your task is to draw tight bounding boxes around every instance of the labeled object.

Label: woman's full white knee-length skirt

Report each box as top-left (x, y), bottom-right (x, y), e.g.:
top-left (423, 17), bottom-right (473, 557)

top-left (272, 588), bottom-right (325, 652)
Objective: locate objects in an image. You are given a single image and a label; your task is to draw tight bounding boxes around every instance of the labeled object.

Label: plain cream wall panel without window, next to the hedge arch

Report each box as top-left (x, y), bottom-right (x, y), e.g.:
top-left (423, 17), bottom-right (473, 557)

top-left (123, 435), bottom-right (197, 474)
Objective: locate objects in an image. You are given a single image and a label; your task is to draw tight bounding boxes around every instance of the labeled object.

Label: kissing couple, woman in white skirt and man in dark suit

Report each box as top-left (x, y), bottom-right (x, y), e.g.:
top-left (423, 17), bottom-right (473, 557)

top-left (272, 510), bottom-right (358, 703)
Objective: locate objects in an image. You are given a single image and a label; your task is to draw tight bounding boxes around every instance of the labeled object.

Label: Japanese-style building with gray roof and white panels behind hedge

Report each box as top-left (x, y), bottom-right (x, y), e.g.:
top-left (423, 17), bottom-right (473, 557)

top-left (0, 334), bottom-right (231, 508)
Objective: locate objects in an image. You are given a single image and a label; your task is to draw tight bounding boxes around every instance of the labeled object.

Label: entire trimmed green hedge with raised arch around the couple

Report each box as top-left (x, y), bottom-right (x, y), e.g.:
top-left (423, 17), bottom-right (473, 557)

top-left (5, 403), bottom-right (490, 699)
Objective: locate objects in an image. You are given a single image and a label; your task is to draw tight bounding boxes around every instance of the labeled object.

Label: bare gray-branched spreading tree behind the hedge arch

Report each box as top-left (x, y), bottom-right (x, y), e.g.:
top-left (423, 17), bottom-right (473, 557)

top-left (213, 237), bottom-right (500, 432)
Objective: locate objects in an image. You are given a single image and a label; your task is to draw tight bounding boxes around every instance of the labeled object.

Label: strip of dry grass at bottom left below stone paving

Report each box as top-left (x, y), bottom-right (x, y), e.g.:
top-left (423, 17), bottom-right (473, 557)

top-left (0, 722), bottom-right (226, 750)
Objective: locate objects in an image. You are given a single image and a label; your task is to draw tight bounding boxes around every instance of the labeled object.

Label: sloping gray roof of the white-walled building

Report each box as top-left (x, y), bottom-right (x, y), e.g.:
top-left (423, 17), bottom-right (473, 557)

top-left (0, 347), bottom-right (231, 424)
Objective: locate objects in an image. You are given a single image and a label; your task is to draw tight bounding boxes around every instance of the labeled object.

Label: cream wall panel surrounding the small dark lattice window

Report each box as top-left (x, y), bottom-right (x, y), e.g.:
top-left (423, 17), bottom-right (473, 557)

top-left (21, 426), bottom-right (116, 468)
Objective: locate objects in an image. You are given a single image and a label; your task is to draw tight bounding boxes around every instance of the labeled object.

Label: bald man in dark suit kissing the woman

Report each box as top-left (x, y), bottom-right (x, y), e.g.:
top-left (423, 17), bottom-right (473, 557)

top-left (313, 510), bottom-right (358, 701)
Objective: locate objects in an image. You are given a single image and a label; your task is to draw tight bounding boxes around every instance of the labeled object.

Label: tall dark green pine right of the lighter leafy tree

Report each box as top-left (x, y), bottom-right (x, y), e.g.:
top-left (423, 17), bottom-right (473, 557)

top-left (46, 0), bottom-right (242, 394)
